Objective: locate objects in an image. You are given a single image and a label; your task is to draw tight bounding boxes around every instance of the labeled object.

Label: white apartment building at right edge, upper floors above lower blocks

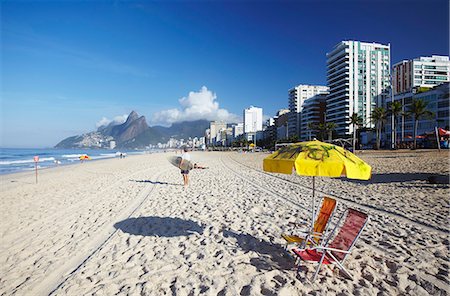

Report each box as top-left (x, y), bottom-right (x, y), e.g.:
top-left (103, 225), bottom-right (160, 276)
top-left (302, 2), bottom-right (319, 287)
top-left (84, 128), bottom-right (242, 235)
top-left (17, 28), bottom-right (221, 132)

top-left (392, 55), bottom-right (450, 95)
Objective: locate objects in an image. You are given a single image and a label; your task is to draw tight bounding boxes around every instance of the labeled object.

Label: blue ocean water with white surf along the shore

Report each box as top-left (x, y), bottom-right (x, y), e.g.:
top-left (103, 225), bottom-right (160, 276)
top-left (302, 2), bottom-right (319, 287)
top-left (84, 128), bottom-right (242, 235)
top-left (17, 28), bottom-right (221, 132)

top-left (0, 148), bottom-right (152, 174)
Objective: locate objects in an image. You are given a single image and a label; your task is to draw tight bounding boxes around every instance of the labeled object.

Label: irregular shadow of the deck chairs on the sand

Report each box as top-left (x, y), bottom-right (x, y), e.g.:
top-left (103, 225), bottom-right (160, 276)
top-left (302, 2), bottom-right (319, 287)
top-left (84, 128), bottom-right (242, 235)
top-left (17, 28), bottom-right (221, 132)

top-left (223, 230), bottom-right (295, 271)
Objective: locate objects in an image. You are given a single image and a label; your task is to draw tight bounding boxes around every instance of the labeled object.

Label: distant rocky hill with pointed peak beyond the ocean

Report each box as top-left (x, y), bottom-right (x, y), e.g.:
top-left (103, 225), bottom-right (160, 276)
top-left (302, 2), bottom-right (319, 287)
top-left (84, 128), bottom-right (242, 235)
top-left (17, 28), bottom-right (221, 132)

top-left (55, 111), bottom-right (209, 149)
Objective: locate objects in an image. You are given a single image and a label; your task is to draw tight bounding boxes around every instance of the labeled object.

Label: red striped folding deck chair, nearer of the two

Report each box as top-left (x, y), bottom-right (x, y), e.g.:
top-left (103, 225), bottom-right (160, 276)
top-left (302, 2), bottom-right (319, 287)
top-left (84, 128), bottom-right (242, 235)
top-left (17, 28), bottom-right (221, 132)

top-left (292, 209), bottom-right (370, 281)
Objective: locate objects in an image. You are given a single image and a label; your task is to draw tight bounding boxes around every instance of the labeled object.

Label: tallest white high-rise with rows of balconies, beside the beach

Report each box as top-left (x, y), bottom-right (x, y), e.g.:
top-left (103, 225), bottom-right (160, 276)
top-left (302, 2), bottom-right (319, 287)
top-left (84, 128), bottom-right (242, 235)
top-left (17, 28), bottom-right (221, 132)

top-left (326, 41), bottom-right (390, 136)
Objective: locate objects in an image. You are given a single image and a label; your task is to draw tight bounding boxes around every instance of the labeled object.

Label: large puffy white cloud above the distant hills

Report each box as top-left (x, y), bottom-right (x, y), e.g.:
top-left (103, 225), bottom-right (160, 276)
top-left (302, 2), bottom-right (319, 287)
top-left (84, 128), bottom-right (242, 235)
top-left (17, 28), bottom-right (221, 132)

top-left (152, 86), bottom-right (241, 125)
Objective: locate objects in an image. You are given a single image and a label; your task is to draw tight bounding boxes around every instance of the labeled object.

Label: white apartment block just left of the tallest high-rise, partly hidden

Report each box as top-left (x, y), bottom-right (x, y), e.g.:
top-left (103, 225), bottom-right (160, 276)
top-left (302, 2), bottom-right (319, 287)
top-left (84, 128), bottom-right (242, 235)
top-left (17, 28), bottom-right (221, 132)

top-left (288, 84), bottom-right (328, 137)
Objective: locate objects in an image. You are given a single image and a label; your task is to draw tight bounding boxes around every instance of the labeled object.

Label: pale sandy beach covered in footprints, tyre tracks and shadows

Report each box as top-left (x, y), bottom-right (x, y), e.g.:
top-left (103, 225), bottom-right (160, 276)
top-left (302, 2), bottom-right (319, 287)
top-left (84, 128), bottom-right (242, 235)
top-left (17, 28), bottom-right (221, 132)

top-left (0, 150), bottom-right (450, 295)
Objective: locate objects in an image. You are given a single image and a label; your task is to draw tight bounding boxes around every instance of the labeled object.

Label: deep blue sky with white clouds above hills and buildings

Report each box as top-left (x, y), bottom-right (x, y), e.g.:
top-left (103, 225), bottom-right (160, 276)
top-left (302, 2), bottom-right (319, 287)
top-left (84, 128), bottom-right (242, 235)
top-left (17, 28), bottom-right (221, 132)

top-left (0, 0), bottom-right (449, 147)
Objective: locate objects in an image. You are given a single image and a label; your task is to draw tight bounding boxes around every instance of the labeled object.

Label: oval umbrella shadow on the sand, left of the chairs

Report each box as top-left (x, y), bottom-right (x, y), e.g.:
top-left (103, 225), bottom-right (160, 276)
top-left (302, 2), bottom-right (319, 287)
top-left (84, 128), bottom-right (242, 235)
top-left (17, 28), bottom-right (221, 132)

top-left (114, 217), bottom-right (204, 237)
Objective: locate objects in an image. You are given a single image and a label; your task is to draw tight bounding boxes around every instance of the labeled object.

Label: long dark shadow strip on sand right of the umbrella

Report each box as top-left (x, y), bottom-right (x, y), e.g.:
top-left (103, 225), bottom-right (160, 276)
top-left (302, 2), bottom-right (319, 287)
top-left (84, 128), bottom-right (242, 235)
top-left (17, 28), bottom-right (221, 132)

top-left (342, 173), bottom-right (449, 184)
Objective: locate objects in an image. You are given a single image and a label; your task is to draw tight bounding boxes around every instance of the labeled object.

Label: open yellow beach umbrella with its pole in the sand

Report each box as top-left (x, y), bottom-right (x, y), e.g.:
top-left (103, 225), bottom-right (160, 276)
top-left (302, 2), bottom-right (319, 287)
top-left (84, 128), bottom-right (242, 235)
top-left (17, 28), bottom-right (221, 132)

top-left (263, 141), bottom-right (372, 232)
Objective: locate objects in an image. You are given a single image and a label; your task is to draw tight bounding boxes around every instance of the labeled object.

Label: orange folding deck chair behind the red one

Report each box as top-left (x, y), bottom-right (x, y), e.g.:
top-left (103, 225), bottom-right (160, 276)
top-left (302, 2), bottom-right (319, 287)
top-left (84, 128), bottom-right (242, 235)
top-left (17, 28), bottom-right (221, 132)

top-left (281, 196), bottom-right (337, 249)
